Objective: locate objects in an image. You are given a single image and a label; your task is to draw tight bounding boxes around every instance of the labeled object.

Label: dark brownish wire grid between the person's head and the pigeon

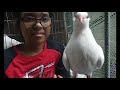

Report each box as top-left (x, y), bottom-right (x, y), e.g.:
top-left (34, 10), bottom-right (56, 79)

top-left (49, 12), bottom-right (67, 44)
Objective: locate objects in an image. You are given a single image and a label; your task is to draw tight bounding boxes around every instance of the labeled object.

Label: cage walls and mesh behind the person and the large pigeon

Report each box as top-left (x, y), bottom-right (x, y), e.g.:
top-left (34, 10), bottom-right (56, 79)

top-left (4, 12), bottom-right (116, 78)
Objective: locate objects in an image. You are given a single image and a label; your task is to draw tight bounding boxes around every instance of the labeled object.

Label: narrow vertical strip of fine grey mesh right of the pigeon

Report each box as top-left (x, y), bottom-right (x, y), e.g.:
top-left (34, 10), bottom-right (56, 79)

top-left (109, 12), bottom-right (116, 78)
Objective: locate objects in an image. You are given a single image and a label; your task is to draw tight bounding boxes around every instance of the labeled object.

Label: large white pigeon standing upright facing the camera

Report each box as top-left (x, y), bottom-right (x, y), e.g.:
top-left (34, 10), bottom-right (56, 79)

top-left (62, 12), bottom-right (104, 78)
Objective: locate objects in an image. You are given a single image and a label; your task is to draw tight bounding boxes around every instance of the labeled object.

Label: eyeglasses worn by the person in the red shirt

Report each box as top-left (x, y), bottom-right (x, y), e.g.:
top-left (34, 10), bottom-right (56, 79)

top-left (21, 16), bottom-right (51, 28)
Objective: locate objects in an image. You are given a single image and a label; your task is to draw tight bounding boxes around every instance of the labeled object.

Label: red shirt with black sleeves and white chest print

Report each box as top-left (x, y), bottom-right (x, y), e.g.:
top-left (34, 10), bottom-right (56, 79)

top-left (4, 40), bottom-right (69, 78)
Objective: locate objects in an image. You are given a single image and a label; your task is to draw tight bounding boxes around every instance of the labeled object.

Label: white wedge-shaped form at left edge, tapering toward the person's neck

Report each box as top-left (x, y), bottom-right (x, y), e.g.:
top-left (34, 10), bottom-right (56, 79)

top-left (4, 34), bottom-right (21, 49)
